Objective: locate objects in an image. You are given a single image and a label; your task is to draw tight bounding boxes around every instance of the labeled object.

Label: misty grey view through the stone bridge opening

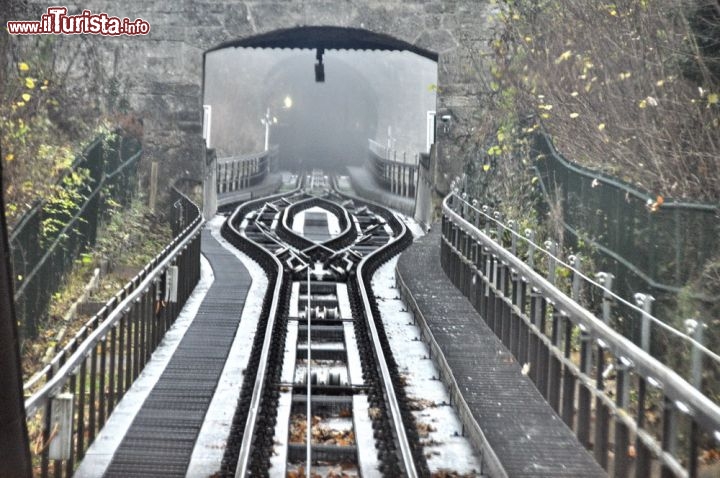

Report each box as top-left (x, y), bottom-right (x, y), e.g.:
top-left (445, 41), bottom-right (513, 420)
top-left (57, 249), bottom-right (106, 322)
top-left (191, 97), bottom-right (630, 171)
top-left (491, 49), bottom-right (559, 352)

top-left (204, 48), bottom-right (437, 169)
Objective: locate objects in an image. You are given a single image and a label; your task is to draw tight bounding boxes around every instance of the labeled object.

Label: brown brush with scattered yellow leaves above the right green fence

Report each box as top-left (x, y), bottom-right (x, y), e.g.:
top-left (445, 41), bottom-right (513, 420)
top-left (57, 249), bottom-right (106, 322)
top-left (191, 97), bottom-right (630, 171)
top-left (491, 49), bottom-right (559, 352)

top-left (478, 0), bottom-right (720, 202)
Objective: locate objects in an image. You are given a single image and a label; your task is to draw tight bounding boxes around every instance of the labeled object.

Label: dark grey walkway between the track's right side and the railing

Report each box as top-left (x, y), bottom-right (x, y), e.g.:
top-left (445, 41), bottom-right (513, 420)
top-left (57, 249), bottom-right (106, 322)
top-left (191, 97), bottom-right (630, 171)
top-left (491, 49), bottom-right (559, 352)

top-left (396, 230), bottom-right (607, 478)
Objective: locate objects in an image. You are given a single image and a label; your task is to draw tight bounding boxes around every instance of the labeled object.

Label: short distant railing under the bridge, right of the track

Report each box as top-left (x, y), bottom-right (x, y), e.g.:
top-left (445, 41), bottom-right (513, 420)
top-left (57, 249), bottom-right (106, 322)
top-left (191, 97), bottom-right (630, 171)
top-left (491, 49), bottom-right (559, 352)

top-left (367, 139), bottom-right (419, 198)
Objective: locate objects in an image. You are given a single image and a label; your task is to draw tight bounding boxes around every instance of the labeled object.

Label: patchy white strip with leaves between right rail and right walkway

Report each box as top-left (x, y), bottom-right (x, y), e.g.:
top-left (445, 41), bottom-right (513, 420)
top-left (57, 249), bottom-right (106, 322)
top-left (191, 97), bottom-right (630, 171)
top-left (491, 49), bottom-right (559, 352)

top-left (372, 256), bottom-right (481, 476)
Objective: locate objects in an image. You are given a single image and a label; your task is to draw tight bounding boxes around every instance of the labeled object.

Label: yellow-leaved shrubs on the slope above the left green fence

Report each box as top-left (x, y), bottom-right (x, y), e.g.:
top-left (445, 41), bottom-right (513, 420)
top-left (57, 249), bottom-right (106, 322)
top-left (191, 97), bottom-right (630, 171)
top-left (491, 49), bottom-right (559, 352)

top-left (0, 15), bottom-right (136, 230)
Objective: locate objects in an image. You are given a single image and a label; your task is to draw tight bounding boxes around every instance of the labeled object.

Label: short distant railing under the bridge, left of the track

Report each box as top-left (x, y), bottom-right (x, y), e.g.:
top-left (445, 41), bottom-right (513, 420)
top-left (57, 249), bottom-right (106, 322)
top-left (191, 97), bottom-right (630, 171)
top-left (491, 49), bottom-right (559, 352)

top-left (216, 146), bottom-right (278, 194)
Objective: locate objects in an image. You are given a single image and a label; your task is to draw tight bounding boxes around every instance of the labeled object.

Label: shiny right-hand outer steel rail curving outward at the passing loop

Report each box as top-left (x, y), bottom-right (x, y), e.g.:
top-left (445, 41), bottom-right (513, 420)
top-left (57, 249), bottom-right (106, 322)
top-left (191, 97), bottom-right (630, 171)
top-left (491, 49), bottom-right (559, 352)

top-left (356, 204), bottom-right (418, 478)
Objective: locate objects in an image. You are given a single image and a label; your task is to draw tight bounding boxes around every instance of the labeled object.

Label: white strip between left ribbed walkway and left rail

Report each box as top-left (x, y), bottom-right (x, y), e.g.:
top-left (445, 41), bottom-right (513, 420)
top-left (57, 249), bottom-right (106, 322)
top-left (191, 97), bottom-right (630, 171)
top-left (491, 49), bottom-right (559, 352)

top-left (186, 216), bottom-right (268, 478)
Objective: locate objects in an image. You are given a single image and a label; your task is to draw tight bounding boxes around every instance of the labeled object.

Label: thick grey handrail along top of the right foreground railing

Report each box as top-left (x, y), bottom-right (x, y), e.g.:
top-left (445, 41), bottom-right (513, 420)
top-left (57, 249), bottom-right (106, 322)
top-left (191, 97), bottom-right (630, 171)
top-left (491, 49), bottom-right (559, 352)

top-left (443, 193), bottom-right (720, 440)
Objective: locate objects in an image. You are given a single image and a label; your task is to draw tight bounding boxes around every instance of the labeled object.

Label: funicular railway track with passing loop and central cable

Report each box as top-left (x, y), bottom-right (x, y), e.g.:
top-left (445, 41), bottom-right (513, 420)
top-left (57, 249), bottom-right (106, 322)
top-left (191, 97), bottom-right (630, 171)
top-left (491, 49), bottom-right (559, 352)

top-left (222, 178), bottom-right (429, 477)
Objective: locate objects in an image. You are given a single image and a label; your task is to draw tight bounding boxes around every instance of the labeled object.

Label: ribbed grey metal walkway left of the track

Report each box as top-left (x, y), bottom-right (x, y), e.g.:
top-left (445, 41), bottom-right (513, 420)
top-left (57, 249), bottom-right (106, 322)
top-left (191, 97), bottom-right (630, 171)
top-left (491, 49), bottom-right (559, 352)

top-left (104, 229), bottom-right (251, 478)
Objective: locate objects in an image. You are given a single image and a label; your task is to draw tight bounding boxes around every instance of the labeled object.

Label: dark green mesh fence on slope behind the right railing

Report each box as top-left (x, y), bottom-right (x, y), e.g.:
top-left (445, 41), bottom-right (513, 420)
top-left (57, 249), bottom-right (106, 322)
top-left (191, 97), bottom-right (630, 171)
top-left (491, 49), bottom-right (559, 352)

top-left (533, 134), bottom-right (720, 298)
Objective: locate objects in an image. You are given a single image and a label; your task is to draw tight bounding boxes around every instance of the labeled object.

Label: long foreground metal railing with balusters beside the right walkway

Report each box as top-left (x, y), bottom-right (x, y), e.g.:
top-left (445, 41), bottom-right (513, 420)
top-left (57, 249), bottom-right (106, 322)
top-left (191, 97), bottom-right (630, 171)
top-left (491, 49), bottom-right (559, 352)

top-left (441, 194), bottom-right (720, 477)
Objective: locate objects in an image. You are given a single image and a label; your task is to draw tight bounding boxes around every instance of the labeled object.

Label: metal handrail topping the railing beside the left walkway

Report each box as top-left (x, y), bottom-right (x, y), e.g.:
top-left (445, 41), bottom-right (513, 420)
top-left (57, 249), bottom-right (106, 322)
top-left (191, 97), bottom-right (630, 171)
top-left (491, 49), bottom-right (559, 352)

top-left (25, 211), bottom-right (205, 416)
